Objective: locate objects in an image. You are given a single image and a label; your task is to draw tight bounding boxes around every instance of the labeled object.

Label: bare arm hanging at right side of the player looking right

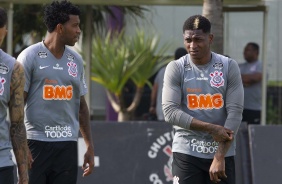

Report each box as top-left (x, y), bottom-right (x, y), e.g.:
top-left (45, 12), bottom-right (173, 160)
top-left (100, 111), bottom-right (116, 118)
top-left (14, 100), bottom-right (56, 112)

top-left (79, 96), bottom-right (94, 176)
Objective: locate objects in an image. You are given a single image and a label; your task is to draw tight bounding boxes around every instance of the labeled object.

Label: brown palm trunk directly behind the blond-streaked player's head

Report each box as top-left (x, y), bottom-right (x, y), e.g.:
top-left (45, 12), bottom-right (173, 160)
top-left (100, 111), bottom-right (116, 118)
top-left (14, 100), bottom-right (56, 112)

top-left (203, 0), bottom-right (223, 54)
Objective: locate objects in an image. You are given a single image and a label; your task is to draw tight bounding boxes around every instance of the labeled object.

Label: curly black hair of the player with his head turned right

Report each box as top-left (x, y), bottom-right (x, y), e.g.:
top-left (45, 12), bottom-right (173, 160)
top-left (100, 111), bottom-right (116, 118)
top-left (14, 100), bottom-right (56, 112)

top-left (43, 0), bottom-right (80, 33)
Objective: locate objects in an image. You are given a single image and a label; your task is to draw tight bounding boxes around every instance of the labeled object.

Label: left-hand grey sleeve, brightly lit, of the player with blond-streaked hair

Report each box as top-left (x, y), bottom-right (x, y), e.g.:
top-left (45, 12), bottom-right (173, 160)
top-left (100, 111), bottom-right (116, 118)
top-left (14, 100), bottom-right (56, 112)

top-left (162, 61), bottom-right (193, 129)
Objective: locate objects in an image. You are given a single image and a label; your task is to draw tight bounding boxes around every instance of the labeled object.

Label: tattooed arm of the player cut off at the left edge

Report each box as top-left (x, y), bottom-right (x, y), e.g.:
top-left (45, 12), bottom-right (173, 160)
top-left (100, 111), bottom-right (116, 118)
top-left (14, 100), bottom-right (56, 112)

top-left (9, 62), bottom-right (28, 184)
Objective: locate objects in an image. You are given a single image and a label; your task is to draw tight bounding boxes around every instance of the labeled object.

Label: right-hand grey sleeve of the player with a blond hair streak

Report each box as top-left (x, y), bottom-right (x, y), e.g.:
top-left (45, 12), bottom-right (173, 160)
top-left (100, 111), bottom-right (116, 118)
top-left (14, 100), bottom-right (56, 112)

top-left (224, 59), bottom-right (244, 134)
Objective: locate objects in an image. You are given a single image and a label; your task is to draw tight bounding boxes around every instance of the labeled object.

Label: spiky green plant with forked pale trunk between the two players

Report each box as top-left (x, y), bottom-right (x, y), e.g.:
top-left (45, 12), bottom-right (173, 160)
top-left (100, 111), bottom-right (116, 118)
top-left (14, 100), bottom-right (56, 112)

top-left (91, 30), bottom-right (171, 122)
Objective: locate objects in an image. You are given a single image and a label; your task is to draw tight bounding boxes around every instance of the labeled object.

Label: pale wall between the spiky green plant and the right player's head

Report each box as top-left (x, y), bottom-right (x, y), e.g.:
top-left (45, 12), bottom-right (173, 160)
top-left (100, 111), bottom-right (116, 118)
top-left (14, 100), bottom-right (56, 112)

top-left (126, 6), bottom-right (202, 56)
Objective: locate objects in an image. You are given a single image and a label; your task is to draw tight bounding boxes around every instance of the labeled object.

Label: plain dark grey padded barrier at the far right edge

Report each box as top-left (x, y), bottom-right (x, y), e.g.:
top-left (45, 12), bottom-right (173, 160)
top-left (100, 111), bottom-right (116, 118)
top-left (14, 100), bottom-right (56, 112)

top-left (249, 125), bottom-right (282, 184)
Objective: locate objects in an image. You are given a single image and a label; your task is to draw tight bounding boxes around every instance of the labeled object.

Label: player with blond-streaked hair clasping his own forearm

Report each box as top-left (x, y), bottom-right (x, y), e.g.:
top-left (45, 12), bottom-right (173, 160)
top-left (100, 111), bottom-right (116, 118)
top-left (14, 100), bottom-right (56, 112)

top-left (162, 15), bottom-right (244, 184)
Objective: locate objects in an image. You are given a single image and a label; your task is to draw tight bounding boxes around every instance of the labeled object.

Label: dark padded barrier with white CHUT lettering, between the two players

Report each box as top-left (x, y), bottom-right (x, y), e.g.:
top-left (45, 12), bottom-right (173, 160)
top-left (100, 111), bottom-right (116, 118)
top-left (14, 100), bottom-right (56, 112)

top-left (77, 121), bottom-right (173, 184)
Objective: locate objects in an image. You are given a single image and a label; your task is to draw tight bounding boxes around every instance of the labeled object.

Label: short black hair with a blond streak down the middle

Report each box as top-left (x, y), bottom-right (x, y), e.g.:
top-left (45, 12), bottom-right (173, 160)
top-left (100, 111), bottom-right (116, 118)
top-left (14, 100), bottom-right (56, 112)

top-left (183, 15), bottom-right (211, 33)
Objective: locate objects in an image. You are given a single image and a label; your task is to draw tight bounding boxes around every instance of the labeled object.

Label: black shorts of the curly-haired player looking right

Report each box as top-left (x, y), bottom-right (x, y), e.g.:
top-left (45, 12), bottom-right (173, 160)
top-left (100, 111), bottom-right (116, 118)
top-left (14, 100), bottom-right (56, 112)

top-left (28, 140), bottom-right (78, 184)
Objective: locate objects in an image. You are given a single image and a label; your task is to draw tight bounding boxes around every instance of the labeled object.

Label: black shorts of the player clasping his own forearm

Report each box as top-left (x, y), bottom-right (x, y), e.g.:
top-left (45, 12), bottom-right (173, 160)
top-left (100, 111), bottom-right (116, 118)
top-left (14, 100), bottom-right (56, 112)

top-left (172, 152), bottom-right (235, 184)
